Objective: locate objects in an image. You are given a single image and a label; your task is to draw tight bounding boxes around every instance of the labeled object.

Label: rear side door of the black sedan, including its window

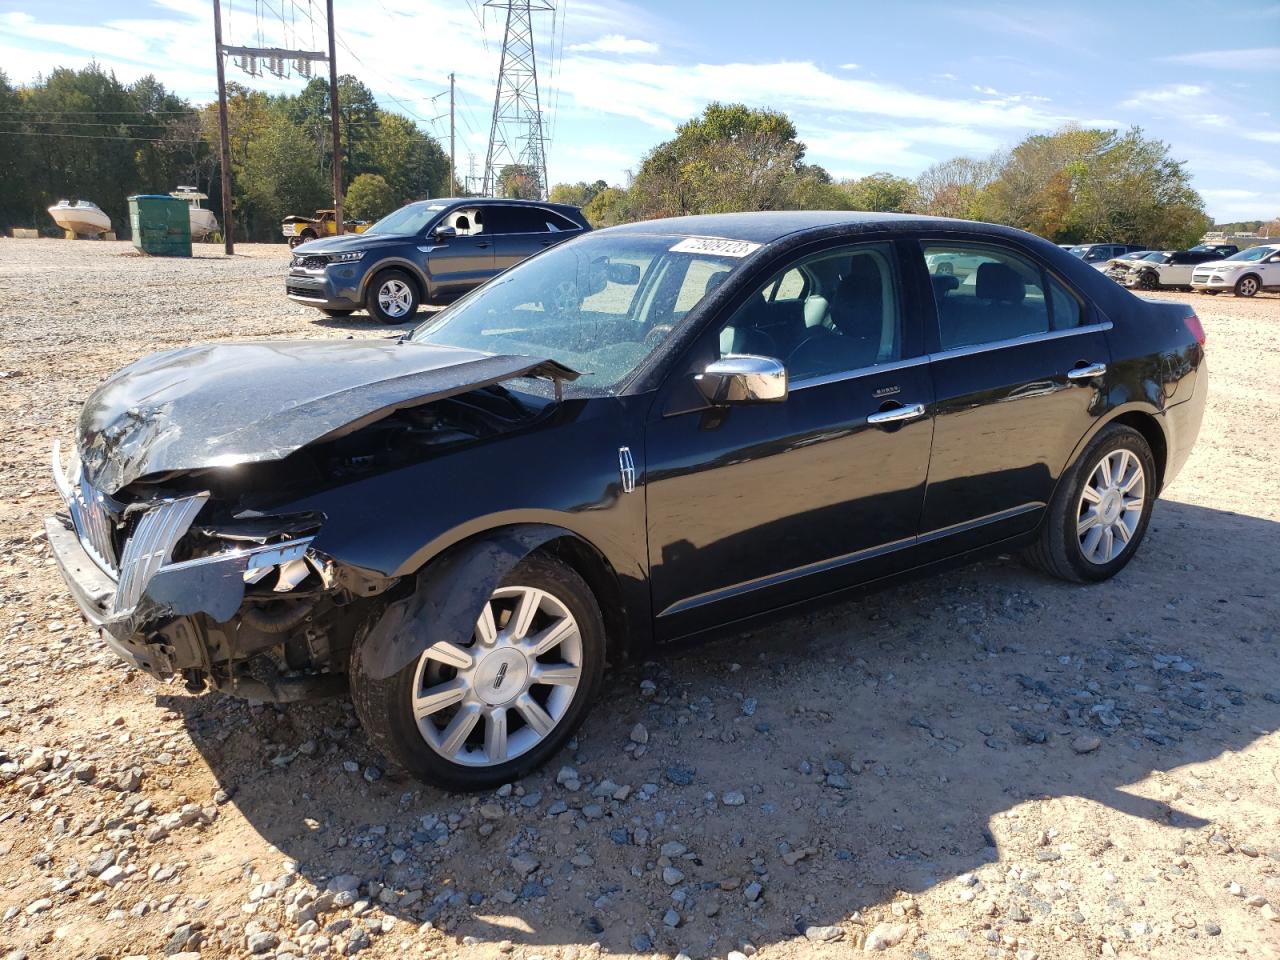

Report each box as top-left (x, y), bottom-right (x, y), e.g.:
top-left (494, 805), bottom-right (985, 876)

top-left (920, 239), bottom-right (1110, 556)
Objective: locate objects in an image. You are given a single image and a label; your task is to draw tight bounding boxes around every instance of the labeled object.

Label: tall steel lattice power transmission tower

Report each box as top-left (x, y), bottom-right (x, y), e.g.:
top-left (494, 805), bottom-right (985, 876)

top-left (484, 0), bottom-right (556, 198)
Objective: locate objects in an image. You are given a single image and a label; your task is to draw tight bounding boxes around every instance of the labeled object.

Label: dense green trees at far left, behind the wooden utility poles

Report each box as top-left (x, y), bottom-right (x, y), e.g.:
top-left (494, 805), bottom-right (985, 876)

top-left (0, 64), bottom-right (452, 241)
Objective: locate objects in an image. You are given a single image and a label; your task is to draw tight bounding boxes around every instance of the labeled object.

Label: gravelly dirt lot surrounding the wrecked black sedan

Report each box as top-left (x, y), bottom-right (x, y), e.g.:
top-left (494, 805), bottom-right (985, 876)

top-left (0, 241), bottom-right (1280, 960)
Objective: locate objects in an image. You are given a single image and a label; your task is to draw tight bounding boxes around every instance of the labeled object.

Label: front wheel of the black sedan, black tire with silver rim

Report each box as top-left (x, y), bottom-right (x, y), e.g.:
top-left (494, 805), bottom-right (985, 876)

top-left (351, 554), bottom-right (605, 792)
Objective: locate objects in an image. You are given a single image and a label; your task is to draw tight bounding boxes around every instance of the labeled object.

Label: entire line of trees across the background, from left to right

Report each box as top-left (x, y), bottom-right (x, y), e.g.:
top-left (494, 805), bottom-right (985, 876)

top-left (0, 64), bottom-right (1249, 248)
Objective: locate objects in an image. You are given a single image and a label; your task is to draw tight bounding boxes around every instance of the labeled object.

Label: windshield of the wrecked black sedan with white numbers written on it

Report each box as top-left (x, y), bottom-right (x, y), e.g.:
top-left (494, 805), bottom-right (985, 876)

top-left (411, 233), bottom-right (756, 396)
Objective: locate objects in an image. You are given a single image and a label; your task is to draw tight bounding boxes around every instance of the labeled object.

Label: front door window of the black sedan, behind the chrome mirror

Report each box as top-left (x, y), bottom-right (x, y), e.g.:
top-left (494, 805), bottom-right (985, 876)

top-left (719, 243), bottom-right (902, 384)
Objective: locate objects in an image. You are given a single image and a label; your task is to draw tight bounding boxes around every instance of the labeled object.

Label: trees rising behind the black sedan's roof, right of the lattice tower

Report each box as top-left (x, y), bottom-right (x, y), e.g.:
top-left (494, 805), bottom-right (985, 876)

top-left (550, 104), bottom-right (1228, 248)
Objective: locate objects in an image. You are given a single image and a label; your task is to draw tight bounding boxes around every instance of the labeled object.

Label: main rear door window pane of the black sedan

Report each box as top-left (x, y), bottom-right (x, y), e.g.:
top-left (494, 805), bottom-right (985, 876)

top-left (922, 241), bottom-right (1048, 349)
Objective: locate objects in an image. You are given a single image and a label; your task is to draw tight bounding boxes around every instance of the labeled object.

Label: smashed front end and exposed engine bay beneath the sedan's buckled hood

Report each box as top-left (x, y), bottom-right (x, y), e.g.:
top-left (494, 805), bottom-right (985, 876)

top-left (46, 384), bottom-right (556, 700)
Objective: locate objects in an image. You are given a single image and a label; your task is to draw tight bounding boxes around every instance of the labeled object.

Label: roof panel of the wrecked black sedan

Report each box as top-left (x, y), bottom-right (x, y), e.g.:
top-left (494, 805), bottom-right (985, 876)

top-left (608, 210), bottom-right (1027, 243)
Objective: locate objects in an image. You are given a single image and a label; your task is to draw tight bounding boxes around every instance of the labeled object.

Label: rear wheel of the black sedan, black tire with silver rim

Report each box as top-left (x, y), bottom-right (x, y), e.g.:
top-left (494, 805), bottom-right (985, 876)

top-left (1023, 424), bottom-right (1157, 584)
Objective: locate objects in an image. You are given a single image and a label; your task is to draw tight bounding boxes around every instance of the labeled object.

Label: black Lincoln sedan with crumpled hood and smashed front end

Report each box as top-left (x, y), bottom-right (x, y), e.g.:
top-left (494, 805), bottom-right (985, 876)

top-left (46, 212), bottom-right (1208, 790)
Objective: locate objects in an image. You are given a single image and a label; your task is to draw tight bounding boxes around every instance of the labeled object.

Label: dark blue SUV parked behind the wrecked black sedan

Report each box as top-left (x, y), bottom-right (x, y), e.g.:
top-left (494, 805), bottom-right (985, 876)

top-left (284, 197), bottom-right (591, 324)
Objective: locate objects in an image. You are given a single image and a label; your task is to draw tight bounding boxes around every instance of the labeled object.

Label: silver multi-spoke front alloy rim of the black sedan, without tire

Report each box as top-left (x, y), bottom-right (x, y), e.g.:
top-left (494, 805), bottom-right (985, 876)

top-left (412, 586), bottom-right (582, 767)
